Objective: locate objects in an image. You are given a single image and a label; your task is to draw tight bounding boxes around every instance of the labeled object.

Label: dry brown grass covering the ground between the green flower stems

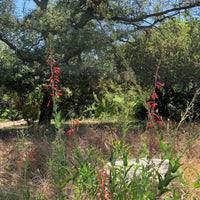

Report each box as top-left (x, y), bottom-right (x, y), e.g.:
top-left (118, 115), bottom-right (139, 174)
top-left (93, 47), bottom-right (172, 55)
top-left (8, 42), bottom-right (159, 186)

top-left (0, 121), bottom-right (200, 199)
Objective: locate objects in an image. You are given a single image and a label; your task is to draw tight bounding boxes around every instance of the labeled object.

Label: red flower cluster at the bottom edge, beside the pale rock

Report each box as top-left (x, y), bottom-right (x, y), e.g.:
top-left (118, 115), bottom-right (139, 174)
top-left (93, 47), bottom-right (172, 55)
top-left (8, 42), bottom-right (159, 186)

top-left (97, 167), bottom-right (115, 200)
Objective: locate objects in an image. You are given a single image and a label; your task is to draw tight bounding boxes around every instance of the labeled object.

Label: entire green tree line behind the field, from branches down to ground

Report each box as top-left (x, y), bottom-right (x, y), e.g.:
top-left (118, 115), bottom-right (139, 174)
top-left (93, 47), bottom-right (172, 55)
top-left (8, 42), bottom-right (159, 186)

top-left (0, 0), bottom-right (200, 122)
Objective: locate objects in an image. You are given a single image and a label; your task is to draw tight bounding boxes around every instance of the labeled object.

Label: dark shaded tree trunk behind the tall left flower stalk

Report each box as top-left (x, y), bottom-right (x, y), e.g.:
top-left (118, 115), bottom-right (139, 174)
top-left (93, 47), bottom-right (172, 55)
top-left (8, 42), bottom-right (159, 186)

top-left (39, 93), bottom-right (53, 124)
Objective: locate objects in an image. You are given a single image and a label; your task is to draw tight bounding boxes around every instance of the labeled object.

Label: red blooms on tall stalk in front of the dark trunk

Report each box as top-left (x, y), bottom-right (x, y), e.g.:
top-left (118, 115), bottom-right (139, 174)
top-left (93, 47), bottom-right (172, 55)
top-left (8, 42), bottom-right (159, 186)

top-left (45, 59), bottom-right (62, 107)
